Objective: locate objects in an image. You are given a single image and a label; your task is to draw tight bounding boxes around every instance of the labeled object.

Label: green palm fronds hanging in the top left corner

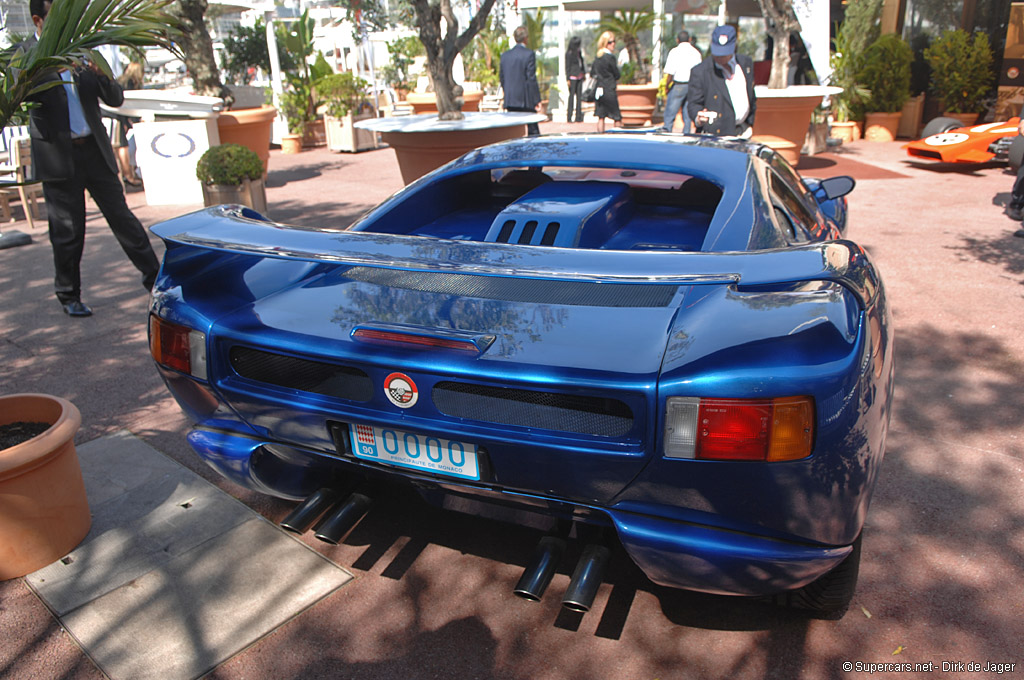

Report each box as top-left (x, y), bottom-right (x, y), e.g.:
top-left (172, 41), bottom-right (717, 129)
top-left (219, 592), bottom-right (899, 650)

top-left (0, 0), bottom-right (177, 127)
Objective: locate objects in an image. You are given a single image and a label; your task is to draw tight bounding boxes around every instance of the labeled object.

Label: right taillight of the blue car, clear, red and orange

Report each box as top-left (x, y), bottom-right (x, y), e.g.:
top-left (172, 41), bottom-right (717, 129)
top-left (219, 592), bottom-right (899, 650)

top-left (665, 396), bottom-right (814, 462)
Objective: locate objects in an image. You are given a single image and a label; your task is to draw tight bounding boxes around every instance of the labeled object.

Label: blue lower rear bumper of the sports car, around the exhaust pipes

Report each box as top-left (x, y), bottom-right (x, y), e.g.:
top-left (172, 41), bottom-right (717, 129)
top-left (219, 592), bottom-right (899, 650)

top-left (188, 428), bottom-right (851, 595)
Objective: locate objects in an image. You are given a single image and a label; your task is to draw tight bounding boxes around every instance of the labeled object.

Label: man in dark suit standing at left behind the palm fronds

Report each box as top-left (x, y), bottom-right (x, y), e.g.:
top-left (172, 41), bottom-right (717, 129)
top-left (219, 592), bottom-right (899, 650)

top-left (29, 0), bottom-right (160, 316)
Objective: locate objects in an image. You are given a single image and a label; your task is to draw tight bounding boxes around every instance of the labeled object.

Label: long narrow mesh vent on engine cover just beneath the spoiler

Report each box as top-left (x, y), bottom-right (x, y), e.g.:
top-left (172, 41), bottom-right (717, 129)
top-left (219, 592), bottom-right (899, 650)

top-left (345, 267), bottom-right (677, 307)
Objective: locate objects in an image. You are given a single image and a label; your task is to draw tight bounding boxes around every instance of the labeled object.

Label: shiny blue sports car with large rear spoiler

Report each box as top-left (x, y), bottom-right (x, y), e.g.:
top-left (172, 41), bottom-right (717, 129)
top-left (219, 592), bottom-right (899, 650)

top-left (150, 132), bottom-right (893, 617)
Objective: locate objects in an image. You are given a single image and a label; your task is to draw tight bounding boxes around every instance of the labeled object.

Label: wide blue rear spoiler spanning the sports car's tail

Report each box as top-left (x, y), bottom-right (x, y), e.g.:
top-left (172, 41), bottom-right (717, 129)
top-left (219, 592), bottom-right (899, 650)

top-left (152, 206), bottom-right (880, 306)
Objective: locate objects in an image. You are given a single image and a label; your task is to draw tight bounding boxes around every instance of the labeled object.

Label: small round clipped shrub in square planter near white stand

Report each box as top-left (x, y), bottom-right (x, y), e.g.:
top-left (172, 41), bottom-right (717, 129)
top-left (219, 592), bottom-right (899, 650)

top-left (196, 144), bottom-right (266, 214)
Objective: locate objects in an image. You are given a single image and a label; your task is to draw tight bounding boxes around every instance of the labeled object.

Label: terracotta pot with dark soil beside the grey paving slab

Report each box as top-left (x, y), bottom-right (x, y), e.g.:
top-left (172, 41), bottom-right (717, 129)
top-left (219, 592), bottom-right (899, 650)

top-left (0, 394), bottom-right (92, 581)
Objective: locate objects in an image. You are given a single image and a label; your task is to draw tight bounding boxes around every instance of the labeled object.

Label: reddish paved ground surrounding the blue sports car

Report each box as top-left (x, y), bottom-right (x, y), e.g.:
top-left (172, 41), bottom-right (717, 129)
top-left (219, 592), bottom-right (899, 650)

top-left (0, 124), bottom-right (1024, 680)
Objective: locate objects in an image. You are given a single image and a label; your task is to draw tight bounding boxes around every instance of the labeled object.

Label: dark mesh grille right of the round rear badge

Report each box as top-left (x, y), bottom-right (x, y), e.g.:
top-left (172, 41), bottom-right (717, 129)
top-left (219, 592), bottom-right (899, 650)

top-left (432, 382), bottom-right (633, 437)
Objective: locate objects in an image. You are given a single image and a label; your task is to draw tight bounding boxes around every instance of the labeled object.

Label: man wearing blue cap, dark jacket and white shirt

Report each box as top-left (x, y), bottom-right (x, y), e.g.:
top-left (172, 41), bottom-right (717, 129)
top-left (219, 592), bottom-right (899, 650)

top-left (686, 25), bottom-right (757, 137)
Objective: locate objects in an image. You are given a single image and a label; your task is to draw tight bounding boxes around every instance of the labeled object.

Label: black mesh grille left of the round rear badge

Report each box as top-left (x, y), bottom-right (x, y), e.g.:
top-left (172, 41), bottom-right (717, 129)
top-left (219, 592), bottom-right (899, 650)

top-left (229, 347), bottom-right (373, 401)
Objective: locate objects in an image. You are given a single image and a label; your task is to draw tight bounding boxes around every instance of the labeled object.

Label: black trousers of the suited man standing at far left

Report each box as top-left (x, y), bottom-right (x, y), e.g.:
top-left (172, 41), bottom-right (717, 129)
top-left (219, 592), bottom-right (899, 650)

top-left (43, 136), bottom-right (160, 302)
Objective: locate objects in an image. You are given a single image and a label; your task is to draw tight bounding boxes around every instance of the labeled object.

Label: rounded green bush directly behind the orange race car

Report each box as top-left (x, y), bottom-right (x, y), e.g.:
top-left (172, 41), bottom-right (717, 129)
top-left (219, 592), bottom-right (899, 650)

top-left (925, 29), bottom-right (994, 114)
